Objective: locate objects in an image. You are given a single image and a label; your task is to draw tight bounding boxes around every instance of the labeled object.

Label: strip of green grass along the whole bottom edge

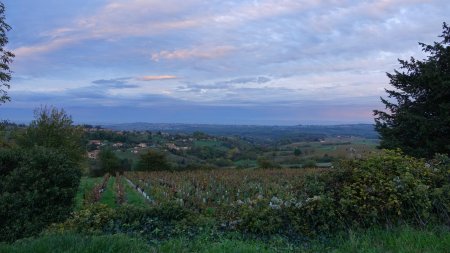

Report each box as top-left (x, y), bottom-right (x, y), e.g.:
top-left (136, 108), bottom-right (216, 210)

top-left (0, 227), bottom-right (450, 253)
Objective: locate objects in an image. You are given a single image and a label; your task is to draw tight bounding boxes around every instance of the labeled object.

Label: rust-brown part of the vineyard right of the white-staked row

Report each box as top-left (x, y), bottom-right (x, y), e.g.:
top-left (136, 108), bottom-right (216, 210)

top-left (125, 169), bottom-right (323, 213)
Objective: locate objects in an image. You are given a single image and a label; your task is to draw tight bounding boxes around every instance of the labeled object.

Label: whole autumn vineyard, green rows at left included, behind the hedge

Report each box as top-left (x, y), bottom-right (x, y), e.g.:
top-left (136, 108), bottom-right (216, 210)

top-left (78, 169), bottom-right (326, 213)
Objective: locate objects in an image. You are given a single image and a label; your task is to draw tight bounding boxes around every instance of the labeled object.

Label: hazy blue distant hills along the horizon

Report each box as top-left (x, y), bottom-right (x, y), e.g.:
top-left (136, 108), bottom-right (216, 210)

top-left (103, 123), bottom-right (378, 141)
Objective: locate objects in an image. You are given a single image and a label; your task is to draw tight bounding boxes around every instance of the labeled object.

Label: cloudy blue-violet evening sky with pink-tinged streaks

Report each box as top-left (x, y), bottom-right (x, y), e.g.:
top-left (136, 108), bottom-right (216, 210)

top-left (0, 0), bottom-right (450, 125)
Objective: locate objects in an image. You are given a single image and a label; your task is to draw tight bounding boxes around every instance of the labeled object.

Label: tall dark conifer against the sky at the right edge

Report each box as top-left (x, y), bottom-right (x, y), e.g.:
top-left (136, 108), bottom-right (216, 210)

top-left (374, 23), bottom-right (450, 158)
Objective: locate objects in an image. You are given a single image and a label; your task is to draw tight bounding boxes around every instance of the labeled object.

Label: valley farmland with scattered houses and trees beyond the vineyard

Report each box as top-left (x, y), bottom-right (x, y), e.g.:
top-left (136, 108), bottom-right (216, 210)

top-left (84, 125), bottom-right (379, 176)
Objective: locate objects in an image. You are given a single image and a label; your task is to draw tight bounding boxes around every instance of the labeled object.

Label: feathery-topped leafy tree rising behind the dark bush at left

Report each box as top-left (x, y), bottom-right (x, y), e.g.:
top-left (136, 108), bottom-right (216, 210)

top-left (19, 107), bottom-right (85, 162)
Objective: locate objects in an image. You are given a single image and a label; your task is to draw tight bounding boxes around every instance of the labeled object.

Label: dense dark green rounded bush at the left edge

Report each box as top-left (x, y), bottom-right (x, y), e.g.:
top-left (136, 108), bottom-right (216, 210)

top-left (0, 147), bottom-right (81, 241)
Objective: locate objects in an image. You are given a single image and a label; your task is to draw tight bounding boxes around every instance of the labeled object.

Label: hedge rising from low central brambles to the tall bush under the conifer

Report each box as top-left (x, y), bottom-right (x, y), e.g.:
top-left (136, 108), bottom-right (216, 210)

top-left (228, 150), bottom-right (450, 238)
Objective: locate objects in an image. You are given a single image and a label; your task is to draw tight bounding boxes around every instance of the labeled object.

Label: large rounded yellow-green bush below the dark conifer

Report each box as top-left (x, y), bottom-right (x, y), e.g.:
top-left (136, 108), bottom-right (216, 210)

top-left (312, 150), bottom-right (449, 227)
